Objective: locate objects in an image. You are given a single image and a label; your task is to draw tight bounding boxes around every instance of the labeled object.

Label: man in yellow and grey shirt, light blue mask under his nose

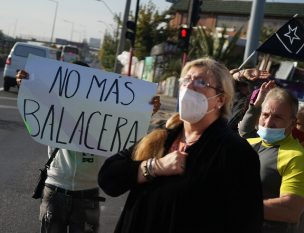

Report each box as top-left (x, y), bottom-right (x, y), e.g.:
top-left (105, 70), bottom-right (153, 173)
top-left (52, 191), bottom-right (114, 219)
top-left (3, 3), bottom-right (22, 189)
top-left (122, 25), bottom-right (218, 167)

top-left (239, 81), bottom-right (304, 233)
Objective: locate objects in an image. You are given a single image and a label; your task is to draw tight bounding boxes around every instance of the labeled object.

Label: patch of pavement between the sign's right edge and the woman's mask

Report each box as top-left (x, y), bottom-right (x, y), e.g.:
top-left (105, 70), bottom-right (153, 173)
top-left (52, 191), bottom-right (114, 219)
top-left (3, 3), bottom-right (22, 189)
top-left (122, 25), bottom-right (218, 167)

top-left (149, 95), bottom-right (177, 131)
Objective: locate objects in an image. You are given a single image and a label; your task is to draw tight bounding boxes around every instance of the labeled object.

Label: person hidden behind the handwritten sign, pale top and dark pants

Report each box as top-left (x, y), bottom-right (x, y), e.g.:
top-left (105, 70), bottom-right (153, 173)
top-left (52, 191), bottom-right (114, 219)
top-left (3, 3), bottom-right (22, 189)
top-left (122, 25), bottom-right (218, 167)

top-left (16, 62), bottom-right (105, 233)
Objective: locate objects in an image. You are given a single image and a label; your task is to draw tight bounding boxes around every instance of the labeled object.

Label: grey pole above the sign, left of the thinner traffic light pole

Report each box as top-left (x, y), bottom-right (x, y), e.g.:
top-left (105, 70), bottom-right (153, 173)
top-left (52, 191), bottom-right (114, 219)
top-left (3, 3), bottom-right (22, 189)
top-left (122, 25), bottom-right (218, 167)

top-left (114, 0), bottom-right (131, 73)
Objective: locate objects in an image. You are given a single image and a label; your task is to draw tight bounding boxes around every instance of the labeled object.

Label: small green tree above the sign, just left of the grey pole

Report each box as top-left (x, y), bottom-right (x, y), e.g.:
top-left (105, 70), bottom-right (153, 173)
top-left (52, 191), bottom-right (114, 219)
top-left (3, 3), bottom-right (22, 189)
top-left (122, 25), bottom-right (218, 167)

top-left (98, 33), bottom-right (117, 71)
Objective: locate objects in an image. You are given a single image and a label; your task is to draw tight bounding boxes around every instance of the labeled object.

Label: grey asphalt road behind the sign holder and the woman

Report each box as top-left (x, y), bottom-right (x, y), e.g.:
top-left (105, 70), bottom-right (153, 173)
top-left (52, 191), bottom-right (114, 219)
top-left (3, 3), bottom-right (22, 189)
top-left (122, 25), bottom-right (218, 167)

top-left (0, 67), bottom-right (176, 233)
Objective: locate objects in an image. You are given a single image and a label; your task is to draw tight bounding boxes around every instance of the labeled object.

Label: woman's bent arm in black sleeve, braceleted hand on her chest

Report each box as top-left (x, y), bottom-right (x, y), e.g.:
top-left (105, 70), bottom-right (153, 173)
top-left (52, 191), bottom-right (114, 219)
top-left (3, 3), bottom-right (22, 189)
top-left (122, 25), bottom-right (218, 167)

top-left (98, 149), bottom-right (187, 196)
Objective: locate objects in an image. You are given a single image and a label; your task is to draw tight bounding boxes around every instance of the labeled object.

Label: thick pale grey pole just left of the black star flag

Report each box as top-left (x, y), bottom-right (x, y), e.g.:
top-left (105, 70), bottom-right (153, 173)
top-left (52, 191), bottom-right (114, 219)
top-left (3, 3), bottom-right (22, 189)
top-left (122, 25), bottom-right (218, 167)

top-left (244, 0), bottom-right (265, 66)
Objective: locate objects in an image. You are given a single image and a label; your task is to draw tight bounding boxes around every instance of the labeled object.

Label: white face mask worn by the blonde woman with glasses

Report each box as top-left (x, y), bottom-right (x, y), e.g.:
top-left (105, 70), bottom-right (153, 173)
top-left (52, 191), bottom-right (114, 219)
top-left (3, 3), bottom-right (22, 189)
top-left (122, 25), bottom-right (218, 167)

top-left (179, 88), bottom-right (220, 124)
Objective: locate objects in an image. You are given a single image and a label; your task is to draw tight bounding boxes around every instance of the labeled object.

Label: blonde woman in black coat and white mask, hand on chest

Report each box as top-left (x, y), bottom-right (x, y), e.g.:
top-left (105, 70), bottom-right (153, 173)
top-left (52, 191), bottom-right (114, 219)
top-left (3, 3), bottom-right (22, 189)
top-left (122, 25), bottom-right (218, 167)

top-left (98, 58), bottom-right (263, 233)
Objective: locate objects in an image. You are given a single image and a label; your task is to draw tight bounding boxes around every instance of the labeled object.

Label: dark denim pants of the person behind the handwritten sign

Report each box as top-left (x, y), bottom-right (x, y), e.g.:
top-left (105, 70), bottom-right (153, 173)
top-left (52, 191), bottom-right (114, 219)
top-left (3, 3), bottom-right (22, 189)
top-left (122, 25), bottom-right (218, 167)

top-left (39, 186), bottom-right (100, 233)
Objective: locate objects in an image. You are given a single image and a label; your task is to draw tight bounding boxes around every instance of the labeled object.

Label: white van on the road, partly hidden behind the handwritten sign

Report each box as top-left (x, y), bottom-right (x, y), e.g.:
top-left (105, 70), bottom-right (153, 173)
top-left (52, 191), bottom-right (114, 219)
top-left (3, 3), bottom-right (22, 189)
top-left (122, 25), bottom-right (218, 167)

top-left (3, 42), bottom-right (56, 91)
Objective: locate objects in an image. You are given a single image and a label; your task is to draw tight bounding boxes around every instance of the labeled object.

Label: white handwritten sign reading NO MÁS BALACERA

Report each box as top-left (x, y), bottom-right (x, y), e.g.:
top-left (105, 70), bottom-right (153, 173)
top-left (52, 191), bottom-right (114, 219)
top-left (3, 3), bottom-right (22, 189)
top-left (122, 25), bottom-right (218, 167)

top-left (18, 55), bottom-right (157, 156)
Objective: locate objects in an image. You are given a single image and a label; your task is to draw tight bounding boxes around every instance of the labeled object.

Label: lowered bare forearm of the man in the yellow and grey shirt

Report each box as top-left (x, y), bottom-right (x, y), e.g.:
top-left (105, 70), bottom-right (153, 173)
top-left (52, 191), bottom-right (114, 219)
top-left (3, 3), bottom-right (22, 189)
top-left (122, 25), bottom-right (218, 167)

top-left (264, 194), bottom-right (304, 223)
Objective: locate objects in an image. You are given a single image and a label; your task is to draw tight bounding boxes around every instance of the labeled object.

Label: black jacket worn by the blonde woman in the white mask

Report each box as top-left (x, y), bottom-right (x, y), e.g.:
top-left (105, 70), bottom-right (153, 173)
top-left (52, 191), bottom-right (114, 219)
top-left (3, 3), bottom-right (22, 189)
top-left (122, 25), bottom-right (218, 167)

top-left (99, 119), bottom-right (263, 233)
